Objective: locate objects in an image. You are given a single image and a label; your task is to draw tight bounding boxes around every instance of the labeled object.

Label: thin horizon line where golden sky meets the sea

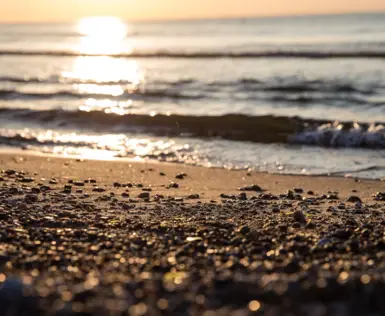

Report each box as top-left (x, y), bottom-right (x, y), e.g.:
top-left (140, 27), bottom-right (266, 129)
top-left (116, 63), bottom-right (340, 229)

top-left (0, 10), bottom-right (385, 24)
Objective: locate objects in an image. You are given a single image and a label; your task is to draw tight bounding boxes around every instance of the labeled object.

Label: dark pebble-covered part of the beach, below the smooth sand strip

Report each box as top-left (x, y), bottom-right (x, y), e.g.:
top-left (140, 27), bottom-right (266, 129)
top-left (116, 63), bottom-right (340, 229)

top-left (0, 167), bottom-right (385, 316)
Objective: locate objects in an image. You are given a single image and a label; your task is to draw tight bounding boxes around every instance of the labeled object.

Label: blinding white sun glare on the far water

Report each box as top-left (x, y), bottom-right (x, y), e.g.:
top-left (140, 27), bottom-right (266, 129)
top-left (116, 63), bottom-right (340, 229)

top-left (61, 17), bottom-right (144, 115)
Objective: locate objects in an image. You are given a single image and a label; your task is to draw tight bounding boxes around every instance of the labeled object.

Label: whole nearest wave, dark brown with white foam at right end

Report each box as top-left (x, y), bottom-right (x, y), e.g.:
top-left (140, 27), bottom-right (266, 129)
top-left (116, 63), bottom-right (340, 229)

top-left (0, 108), bottom-right (385, 148)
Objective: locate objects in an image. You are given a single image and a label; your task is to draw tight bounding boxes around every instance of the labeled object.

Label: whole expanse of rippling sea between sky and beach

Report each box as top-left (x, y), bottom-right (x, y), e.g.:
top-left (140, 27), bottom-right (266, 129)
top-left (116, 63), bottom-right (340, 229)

top-left (0, 13), bottom-right (385, 178)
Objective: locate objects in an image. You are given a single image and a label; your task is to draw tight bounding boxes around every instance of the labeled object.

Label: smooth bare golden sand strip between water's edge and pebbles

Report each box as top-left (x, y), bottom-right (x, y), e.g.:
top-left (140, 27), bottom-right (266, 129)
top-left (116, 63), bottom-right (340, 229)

top-left (0, 150), bottom-right (385, 200)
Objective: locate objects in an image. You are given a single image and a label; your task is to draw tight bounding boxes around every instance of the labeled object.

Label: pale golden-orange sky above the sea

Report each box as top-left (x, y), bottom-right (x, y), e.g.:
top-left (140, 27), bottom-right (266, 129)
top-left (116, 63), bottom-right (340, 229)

top-left (0, 0), bottom-right (385, 22)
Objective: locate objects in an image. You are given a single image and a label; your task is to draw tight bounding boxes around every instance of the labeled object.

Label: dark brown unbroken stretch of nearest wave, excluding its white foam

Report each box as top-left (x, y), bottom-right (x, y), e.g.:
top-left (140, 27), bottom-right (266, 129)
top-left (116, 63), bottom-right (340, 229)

top-left (0, 108), bottom-right (302, 143)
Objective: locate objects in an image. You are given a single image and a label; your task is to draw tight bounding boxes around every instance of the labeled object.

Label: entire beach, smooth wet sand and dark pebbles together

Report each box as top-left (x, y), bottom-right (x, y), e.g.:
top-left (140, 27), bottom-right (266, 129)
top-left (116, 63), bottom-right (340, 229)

top-left (0, 153), bottom-right (385, 316)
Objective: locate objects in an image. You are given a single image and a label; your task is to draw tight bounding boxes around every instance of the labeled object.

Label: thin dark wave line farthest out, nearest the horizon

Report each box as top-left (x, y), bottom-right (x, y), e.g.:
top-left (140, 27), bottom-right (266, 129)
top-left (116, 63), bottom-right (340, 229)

top-left (0, 50), bottom-right (385, 59)
